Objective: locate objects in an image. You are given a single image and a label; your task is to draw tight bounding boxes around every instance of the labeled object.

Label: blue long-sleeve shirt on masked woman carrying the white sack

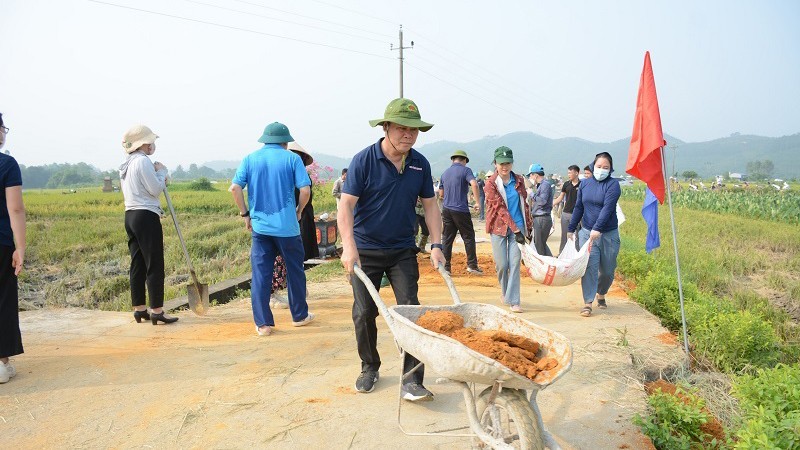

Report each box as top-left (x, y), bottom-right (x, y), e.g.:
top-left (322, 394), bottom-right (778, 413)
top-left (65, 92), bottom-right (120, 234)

top-left (568, 176), bottom-right (622, 233)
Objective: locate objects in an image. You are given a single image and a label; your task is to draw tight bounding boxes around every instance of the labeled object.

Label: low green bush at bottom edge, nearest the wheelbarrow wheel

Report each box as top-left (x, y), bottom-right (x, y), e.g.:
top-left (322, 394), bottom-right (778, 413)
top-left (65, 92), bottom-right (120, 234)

top-left (633, 388), bottom-right (723, 450)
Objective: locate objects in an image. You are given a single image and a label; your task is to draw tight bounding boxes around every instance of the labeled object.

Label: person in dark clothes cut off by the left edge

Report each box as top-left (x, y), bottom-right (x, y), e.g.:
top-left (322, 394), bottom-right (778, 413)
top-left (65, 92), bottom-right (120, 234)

top-left (0, 114), bottom-right (25, 384)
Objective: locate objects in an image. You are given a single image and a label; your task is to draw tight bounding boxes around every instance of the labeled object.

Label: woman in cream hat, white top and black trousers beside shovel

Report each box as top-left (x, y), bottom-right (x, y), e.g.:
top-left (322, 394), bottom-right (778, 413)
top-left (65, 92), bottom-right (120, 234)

top-left (119, 125), bottom-right (178, 325)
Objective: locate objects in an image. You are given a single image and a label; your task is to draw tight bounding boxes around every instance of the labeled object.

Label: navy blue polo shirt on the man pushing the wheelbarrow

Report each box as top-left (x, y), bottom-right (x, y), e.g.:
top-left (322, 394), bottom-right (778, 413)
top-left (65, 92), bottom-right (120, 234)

top-left (342, 138), bottom-right (433, 249)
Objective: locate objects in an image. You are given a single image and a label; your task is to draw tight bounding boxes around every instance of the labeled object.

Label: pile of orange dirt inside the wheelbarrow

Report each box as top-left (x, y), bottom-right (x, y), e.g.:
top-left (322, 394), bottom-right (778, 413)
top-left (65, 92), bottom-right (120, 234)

top-left (417, 311), bottom-right (558, 380)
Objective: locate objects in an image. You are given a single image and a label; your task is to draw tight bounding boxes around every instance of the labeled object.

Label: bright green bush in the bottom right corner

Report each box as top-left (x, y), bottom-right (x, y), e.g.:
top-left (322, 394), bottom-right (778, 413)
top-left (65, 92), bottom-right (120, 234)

top-left (733, 364), bottom-right (800, 449)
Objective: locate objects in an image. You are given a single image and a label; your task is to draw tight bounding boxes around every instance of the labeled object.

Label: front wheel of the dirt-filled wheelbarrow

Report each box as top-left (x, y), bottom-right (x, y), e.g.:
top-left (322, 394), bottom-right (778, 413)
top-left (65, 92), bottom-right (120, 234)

top-left (476, 387), bottom-right (544, 450)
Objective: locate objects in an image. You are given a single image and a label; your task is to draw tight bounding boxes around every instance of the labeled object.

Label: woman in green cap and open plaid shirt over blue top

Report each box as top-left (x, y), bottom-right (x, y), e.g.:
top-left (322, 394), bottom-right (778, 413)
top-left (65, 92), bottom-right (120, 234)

top-left (483, 147), bottom-right (533, 313)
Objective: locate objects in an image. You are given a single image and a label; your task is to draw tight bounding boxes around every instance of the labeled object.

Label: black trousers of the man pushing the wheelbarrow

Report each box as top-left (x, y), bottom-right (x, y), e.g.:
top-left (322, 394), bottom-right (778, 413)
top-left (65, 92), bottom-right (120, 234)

top-left (350, 248), bottom-right (425, 384)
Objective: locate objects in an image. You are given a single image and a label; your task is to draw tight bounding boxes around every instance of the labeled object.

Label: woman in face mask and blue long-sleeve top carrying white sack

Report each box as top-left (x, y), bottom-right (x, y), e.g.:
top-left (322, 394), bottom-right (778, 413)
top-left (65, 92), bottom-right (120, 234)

top-left (568, 152), bottom-right (622, 317)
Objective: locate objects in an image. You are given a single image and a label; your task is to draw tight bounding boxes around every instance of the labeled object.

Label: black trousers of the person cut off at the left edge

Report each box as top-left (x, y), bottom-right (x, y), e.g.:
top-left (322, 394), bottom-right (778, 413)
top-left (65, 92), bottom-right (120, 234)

top-left (0, 246), bottom-right (22, 358)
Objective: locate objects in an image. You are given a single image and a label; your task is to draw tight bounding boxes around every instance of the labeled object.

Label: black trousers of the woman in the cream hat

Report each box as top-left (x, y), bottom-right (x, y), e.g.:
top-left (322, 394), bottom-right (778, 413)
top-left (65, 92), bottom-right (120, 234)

top-left (125, 209), bottom-right (164, 308)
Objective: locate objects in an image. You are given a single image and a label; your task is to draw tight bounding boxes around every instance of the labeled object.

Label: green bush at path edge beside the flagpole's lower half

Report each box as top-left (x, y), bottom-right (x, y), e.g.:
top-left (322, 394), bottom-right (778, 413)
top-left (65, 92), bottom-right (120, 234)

top-left (630, 270), bottom-right (698, 331)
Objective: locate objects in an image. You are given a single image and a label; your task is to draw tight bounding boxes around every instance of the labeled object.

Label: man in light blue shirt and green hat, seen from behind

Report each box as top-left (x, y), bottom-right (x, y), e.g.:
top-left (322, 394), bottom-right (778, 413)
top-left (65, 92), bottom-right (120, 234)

top-left (230, 122), bottom-right (314, 336)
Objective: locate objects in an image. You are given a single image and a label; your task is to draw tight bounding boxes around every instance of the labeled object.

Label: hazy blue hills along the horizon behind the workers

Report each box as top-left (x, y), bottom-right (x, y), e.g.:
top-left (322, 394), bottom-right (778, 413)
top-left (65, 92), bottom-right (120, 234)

top-left (203, 132), bottom-right (800, 179)
